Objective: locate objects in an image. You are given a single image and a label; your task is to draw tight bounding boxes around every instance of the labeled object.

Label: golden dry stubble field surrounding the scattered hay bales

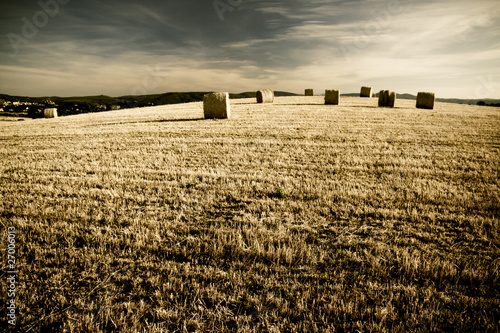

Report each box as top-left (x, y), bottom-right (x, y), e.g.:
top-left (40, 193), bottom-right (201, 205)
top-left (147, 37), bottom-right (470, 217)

top-left (0, 97), bottom-right (500, 332)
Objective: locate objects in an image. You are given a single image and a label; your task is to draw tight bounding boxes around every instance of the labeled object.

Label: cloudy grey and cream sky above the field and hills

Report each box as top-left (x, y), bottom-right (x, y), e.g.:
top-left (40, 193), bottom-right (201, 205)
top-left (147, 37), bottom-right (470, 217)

top-left (0, 0), bottom-right (500, 99)
